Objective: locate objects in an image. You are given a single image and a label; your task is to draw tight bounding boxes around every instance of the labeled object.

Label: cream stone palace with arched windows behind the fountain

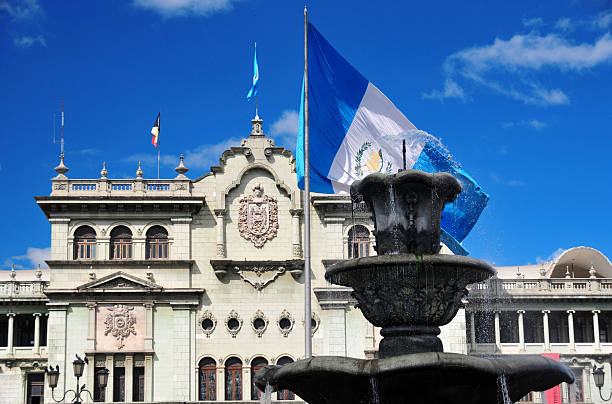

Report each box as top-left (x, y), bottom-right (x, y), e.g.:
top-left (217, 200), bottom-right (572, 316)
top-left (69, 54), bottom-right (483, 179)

top-left (0, 117), bottom-right (612, 404)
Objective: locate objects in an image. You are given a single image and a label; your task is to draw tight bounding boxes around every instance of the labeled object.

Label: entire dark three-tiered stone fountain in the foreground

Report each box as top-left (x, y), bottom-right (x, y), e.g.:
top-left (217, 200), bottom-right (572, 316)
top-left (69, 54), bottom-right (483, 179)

top-left (255, 170), bottom-right (574, 404)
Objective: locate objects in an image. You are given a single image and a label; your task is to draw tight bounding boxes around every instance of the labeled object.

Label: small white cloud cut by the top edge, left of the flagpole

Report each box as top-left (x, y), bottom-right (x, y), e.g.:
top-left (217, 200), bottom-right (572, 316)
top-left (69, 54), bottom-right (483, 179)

top-left (132, 0), bottom-right (239, 18)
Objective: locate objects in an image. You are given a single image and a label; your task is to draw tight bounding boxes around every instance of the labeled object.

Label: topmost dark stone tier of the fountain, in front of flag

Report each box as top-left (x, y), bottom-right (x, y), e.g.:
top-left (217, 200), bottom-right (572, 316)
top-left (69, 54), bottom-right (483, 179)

top-left (351, 170), bottom-right (461, 255)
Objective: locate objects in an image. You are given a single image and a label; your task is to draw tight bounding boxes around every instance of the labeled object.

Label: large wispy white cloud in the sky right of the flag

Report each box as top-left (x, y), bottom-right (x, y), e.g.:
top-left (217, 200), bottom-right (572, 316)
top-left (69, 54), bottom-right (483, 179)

top-left (423, 31), bottom-right (612, 105)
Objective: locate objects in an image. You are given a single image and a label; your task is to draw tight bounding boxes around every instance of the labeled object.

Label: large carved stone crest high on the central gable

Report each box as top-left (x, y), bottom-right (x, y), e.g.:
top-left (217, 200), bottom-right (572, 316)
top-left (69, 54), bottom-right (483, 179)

top-left (238, 183), bottom-right (278, 248)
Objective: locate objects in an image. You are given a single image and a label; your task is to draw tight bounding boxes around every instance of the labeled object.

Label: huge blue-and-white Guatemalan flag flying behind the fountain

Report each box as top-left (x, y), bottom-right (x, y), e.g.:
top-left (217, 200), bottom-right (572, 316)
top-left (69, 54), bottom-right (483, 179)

top-left (296, 24), bottom-right (489, 255)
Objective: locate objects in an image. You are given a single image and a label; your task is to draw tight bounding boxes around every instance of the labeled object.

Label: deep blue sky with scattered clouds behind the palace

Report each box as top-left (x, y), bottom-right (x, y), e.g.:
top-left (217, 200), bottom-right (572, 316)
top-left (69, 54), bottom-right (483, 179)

top-left (0, 0), bottom-right (612, 268)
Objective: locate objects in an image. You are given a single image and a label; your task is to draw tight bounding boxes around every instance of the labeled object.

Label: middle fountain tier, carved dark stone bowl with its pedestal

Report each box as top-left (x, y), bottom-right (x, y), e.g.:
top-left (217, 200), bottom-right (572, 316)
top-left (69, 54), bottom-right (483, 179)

top-left (325, 254), bottom-right (495, 358)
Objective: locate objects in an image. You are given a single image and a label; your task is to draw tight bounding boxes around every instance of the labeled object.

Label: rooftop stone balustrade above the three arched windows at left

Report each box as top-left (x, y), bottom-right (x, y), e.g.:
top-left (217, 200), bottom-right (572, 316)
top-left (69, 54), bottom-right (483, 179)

top-left (51, 178), bottom-right (191, 197)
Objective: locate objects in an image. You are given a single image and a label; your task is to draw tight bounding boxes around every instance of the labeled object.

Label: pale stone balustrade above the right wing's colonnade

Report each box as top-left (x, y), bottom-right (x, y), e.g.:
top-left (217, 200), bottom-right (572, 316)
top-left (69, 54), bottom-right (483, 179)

top-left (468, 278), bottom-right (612, 297)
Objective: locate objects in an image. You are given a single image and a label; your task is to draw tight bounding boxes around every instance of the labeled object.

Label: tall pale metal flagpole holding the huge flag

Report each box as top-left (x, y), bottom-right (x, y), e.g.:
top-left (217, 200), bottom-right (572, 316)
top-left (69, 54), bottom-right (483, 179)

top-left (304, 6), bottom-right (312, 358)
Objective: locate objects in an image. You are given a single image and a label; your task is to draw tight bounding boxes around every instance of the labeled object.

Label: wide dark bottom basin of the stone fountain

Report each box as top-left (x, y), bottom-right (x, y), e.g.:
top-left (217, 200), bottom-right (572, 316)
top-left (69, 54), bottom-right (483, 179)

top-left (254, 352), bottom-right (574, 404)
